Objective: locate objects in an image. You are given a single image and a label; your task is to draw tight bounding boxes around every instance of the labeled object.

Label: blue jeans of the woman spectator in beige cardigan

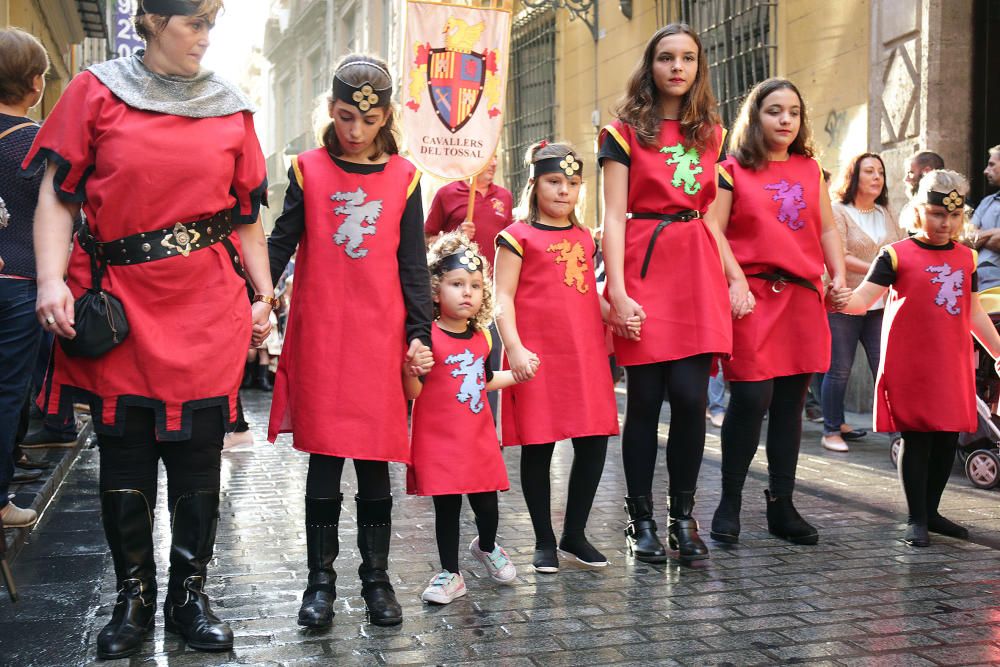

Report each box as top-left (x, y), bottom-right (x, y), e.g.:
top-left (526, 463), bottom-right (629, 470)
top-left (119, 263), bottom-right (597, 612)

top-left (821, 308), bottom-right (884, 434)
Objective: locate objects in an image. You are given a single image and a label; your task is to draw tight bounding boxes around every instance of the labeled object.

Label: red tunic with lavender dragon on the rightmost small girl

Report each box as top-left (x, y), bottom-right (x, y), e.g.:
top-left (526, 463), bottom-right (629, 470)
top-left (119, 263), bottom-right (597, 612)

top-left (875, 239), bottom-right (976, 432)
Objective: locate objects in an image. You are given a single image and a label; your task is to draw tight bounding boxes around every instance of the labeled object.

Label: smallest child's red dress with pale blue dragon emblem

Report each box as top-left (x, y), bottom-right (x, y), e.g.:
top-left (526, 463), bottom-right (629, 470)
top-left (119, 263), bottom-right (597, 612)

top-left (406, 325), bottom-right (510, 496)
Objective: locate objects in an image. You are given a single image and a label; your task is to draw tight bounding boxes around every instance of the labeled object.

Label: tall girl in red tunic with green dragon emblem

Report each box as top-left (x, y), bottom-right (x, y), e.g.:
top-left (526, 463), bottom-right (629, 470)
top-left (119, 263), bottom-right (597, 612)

top-left (599, 23), bottom-right (732, 563)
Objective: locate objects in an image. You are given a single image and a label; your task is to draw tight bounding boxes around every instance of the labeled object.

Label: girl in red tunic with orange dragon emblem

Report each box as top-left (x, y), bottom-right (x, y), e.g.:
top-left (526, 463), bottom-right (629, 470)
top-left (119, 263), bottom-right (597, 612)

top-left (496, 141), bottom-right (624, 572)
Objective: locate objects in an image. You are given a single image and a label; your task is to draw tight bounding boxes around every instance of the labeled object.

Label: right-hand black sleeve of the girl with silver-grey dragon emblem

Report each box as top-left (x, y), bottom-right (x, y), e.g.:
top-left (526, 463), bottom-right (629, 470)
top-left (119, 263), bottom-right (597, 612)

top-left (396, 183), bottom-right (433, 347)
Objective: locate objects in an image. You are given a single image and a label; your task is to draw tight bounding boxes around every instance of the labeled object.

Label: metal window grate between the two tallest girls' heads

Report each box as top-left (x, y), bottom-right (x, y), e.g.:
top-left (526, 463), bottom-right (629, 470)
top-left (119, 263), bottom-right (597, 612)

top-left (680, 0), bottom-right (778, 125)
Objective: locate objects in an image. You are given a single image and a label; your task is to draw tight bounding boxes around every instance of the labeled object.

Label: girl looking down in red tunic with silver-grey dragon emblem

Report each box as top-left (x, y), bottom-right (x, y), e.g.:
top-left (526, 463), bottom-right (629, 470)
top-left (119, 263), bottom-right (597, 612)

top-left (268, 55), bottom-right (433, 627)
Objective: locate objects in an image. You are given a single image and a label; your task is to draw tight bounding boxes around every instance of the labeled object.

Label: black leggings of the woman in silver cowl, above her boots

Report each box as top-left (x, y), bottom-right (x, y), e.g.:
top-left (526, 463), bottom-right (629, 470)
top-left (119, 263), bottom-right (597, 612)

top-left (97, 407), bottom-right (226, 512)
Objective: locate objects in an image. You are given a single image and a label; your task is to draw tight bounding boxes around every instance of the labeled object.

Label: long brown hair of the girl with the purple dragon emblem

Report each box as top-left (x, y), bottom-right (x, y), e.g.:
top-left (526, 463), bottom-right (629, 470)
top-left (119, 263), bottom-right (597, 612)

top-left (729, 77), bottom-right (815, 171)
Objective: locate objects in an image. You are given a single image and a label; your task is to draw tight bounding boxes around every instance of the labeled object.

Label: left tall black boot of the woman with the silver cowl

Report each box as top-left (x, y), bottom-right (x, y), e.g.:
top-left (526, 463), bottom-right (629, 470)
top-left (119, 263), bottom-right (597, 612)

top-left (97, 489), bottom-right (156, 660)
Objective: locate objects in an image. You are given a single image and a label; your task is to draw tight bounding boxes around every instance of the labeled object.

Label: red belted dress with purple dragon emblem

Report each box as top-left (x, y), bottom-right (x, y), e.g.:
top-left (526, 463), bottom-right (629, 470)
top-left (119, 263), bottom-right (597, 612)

top-left (719, 154), bottom-right (830, 382)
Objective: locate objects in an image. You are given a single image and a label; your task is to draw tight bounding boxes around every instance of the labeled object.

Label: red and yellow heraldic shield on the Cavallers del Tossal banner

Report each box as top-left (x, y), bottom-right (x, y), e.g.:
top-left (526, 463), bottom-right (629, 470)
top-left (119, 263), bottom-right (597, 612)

top-left (427, 49), bottom-right (486, 132)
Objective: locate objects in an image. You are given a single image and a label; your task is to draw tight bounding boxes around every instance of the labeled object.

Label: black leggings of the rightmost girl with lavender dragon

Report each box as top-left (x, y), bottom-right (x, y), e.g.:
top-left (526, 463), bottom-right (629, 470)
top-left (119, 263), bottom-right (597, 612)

top-left (899, 431), bottom-right (958, 526)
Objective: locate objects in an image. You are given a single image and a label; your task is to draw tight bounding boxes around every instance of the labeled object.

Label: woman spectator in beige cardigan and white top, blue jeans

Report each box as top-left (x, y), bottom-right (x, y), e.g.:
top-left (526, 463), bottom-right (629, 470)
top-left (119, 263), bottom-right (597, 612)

top-left (821, 153), bottom-right (906, 452)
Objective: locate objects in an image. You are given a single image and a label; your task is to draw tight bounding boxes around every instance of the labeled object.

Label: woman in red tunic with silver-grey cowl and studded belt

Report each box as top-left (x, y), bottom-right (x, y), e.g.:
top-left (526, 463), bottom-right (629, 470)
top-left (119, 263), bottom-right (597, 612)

top-left (24, 0), bottom-right (273, 658)
